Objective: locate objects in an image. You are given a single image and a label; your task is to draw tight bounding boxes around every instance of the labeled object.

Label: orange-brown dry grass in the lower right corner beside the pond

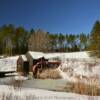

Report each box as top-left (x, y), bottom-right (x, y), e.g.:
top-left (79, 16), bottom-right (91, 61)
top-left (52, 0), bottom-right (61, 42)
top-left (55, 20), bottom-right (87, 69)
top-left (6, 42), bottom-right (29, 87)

top-left (62, 81), bottom-right (100, 96)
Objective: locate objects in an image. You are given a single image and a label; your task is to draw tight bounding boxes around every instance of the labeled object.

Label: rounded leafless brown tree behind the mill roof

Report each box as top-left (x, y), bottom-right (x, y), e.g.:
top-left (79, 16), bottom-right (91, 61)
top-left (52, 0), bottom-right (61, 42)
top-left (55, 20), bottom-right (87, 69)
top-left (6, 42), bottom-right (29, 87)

top-left (28, 29), bottom-right (49, 52)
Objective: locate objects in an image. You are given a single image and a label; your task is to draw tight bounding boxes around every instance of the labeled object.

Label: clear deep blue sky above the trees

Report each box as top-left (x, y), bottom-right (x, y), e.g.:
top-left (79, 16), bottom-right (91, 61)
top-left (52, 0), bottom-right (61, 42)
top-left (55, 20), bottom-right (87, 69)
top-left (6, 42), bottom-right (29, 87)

top-left (0, 0), bottom-right (100, 34)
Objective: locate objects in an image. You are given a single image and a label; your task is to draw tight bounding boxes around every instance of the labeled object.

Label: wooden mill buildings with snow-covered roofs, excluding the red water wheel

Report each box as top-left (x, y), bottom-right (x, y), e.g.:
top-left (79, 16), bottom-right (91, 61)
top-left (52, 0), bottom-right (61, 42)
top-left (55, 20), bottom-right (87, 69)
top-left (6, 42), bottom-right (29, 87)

top-left (17, 51), bottom-right (48, 75)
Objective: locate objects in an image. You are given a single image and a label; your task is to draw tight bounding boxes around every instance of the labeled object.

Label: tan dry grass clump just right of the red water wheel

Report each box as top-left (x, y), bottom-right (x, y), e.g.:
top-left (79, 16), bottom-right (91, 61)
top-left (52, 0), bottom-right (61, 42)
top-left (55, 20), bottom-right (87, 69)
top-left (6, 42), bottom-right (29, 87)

top-left (38, 69), bottom-right (61, 79)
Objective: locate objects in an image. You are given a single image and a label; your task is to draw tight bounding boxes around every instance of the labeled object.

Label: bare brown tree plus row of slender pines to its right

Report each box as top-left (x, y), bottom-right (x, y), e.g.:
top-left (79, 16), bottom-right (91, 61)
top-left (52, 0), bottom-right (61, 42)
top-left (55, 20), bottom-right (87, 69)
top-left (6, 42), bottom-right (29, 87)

top-left (28, 29), bottom-right (89, 52)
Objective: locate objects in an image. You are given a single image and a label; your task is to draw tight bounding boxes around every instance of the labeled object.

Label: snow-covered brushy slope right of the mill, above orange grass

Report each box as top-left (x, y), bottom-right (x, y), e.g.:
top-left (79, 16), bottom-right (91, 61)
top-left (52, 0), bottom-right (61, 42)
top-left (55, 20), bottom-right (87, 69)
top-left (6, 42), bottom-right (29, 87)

top-left (58, 60), bottom-right (100, 86)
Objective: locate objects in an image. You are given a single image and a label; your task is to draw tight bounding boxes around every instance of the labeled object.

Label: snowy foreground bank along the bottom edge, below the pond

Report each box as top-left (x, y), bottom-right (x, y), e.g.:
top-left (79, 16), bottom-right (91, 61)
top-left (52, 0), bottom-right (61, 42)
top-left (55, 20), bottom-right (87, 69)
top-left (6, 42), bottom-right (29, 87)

top-left (0, 85), bottom-right (100, 100)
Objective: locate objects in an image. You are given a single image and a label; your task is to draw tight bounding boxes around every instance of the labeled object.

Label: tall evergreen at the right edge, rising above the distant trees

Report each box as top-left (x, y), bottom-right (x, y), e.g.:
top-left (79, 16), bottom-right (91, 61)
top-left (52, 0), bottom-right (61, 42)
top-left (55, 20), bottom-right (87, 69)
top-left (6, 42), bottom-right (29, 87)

top-left (90, 20), bottom-right (100, 57)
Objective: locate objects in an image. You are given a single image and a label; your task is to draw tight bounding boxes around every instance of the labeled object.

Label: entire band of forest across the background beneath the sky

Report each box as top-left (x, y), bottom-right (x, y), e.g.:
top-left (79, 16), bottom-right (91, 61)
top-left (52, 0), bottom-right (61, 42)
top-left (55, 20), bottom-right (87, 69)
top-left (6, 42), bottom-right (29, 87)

top-left (0, 21), bottom-right (100, 56)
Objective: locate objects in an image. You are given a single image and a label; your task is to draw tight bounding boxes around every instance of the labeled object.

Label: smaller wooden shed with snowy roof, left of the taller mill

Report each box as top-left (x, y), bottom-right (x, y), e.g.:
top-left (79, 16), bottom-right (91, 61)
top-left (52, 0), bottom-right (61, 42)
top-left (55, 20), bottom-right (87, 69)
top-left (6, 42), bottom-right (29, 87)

top-left (17, 55), bottom-right (29, 75)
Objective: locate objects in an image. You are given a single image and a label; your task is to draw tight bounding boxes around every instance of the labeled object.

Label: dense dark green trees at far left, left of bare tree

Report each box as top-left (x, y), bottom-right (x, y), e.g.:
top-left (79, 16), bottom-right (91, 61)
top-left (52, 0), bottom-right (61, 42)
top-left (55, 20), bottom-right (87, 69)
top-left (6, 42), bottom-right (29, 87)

top-left (0, 24), bottom-right (29, 55)
